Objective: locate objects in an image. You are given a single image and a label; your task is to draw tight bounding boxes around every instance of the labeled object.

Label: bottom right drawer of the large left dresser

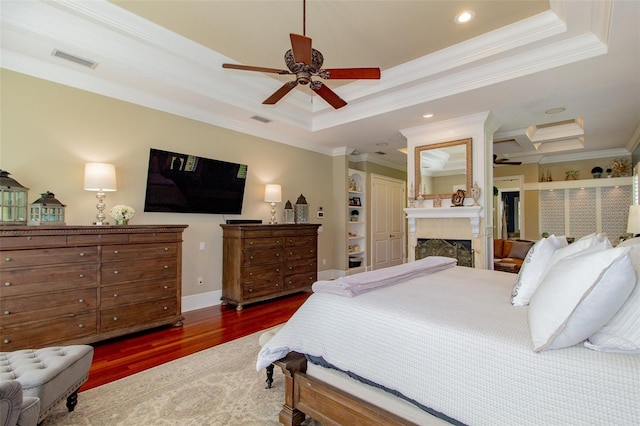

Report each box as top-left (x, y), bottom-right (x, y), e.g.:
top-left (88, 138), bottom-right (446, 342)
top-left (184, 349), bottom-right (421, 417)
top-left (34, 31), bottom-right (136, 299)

top-left (100, 296), bottom-right (179, 333)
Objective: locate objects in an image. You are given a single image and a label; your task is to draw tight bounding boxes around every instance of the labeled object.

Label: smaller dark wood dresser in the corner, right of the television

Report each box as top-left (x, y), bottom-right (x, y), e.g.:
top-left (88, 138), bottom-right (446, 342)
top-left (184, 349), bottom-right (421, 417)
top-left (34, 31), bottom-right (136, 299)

top-left (220, 224), bottom-right (320, 310)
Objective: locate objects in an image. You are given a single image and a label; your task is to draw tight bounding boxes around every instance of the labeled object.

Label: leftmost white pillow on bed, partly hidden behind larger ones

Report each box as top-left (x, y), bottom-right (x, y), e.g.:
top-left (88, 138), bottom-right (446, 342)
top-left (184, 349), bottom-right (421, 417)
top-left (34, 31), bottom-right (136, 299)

top-left (511, 235), bottom-right (567, 306)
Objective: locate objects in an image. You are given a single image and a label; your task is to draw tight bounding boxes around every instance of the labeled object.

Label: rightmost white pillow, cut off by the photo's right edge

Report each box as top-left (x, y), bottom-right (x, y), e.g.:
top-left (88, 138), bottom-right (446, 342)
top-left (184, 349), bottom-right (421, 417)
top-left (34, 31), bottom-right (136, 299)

top-left (584, 246), bottom-right (640, 354)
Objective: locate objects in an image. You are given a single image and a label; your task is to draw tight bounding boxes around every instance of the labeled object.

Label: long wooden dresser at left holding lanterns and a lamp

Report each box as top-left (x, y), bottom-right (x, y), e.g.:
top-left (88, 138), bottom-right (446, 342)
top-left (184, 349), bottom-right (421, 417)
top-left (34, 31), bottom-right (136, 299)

top-left (0, 225), bottom-right (186, 351)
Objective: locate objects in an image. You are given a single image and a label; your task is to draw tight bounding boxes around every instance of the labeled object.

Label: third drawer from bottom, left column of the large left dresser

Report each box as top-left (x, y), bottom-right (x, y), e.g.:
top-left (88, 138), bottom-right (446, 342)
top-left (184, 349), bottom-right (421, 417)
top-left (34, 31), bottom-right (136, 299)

top-left (0, 263), bottom-right (98, 297)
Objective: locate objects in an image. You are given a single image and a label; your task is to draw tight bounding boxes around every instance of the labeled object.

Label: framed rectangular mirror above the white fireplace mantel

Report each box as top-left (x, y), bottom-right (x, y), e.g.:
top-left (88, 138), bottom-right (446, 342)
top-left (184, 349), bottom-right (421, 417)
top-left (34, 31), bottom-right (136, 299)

top-left (415, 138), bottom-right (473, 199)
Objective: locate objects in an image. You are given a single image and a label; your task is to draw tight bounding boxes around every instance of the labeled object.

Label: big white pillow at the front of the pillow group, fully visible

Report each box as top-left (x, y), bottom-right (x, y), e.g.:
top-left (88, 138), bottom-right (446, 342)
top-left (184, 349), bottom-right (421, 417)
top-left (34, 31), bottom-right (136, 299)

top-left (529, 247), bottom-right (636, 352)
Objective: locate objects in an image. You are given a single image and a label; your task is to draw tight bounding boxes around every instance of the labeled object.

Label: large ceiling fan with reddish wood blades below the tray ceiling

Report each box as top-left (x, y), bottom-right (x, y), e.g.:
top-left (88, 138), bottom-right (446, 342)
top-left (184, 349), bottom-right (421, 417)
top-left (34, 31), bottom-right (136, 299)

top-left (222, 0), bottom-right (380, 109)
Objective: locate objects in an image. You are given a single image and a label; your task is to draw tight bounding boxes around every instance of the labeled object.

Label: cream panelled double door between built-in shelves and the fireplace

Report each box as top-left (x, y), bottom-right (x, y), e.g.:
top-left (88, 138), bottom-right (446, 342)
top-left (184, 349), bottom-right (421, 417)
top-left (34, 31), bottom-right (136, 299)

top-left (371, 175), bottom-right (405, 269)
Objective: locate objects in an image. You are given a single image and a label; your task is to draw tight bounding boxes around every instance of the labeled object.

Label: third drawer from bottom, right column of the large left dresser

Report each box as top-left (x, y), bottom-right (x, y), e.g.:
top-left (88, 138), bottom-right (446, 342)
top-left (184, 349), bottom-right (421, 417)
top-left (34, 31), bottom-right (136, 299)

top-left (100, 257), bottom-right (178, 285)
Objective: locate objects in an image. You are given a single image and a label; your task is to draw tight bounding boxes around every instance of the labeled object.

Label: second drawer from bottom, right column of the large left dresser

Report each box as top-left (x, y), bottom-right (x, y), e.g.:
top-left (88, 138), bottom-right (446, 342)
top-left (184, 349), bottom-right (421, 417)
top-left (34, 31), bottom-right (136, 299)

top-left (100, 278), bottom-right (176, 308)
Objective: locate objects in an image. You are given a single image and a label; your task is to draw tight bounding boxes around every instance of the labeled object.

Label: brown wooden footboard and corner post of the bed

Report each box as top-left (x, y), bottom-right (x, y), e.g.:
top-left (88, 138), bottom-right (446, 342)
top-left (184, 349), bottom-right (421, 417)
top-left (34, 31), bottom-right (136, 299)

top-left (274, 352), bottom-right (414, 426)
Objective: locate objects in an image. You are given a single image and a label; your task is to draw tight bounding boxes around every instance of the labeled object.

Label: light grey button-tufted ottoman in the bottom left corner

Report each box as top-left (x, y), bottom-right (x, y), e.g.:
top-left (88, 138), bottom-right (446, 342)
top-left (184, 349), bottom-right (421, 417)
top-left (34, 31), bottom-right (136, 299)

top-left (0, 345), bottom-right (93, 423)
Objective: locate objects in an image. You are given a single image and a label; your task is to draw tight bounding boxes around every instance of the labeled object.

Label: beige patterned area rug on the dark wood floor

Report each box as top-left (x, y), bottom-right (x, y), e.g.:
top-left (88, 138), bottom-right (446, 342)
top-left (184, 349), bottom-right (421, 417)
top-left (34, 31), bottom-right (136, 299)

top-left (41, 333), bottom-right (316, 426)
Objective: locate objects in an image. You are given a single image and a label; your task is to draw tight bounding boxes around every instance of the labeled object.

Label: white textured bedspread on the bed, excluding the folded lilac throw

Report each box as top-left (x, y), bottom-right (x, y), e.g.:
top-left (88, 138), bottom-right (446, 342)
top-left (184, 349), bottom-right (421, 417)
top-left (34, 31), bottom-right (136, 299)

top-left (257, 267), bottom-right (640, 425)
